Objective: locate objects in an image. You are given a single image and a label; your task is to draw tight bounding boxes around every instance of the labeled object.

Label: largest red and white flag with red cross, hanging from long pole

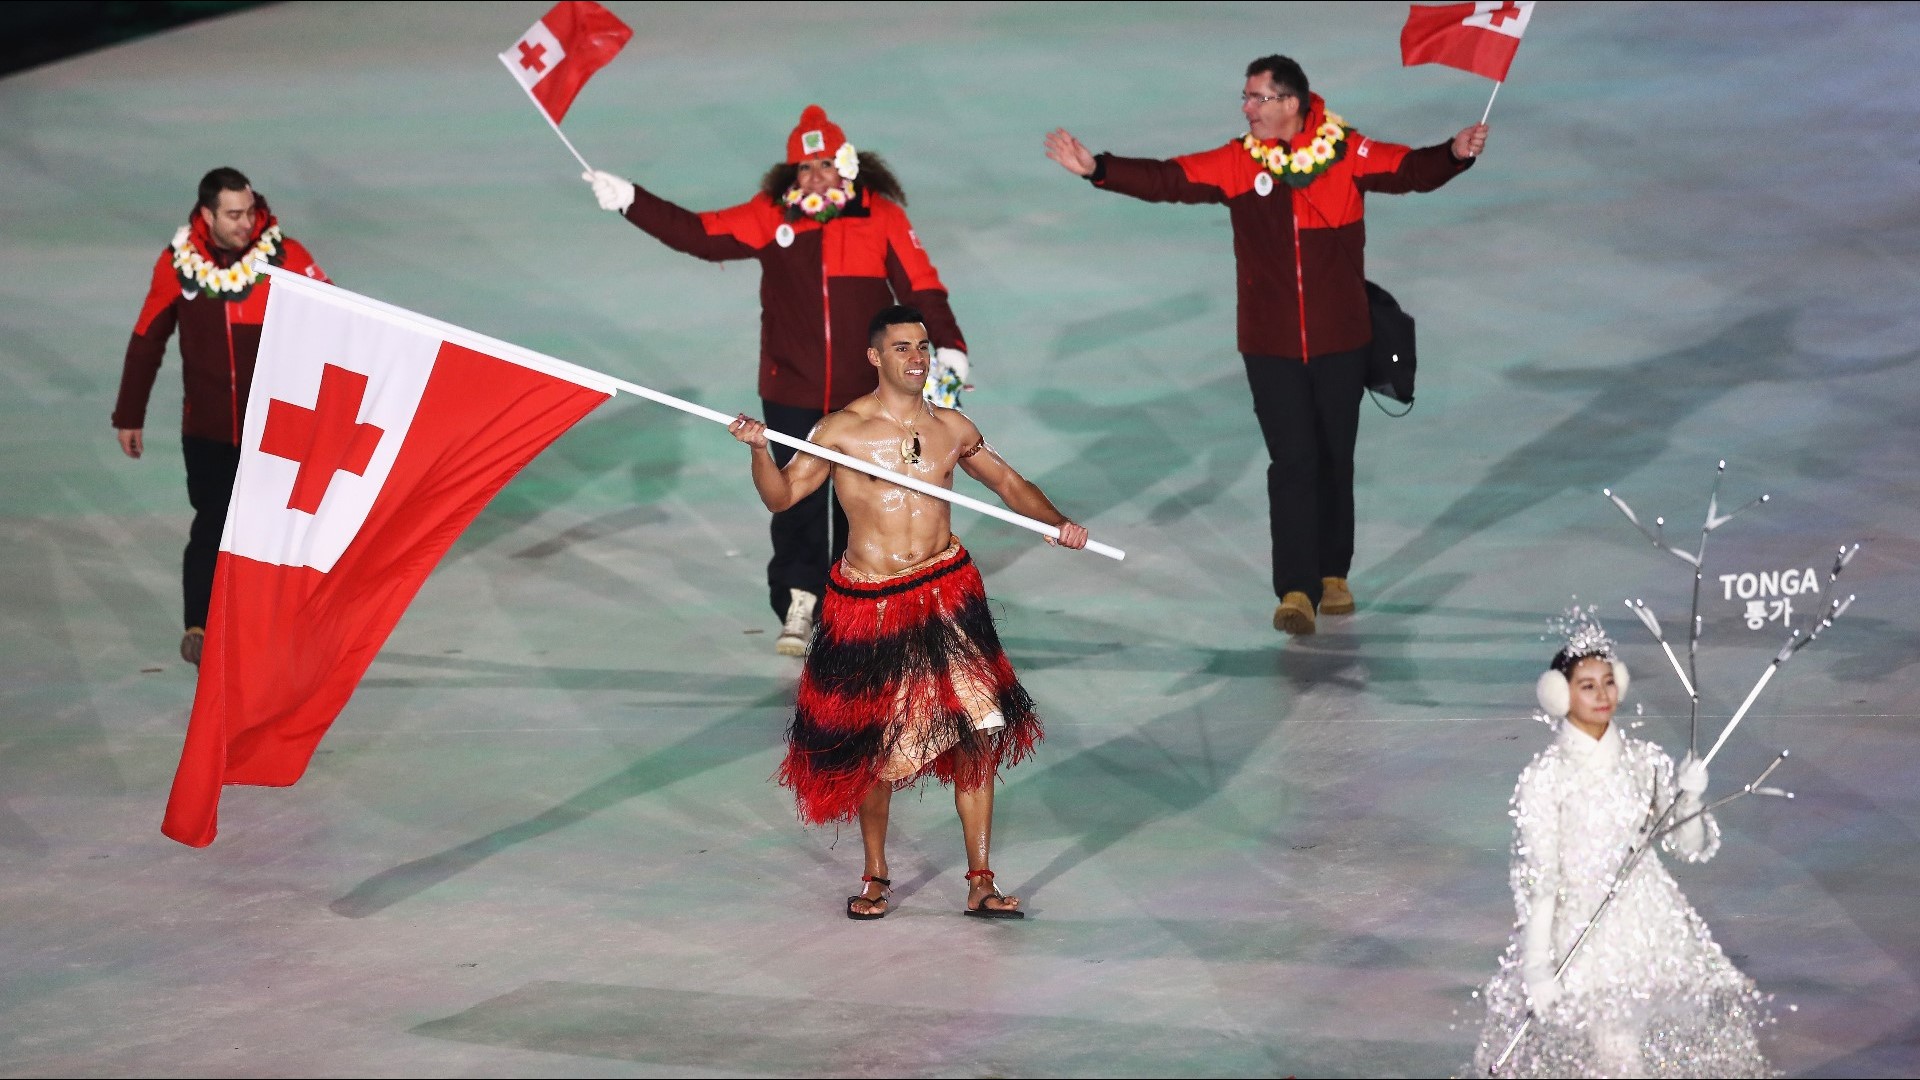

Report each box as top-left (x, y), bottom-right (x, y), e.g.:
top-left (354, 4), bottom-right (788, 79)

top-left (161, 269), bottom-right (614, 847)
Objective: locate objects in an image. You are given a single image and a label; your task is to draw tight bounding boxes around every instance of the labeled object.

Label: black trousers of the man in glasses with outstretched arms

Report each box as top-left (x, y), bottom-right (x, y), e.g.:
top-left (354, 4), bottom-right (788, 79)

top-left (1240, 350), bottom-right (1367, 607)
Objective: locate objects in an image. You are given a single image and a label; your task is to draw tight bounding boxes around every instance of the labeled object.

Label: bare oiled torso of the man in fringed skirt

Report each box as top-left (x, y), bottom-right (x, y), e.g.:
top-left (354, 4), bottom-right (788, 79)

top-left (812, 396), bottom-right (979, 575)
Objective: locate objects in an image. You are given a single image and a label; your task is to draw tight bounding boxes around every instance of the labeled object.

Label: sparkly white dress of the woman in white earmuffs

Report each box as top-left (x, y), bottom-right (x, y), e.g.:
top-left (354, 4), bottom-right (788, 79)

top-left (1473, 723), bottom-right (1774, 1076)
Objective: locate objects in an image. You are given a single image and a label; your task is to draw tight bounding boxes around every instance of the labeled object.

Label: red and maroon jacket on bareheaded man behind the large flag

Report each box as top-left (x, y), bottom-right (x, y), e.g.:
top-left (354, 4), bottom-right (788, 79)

top-left (113, 198), bottom-right (326, 446)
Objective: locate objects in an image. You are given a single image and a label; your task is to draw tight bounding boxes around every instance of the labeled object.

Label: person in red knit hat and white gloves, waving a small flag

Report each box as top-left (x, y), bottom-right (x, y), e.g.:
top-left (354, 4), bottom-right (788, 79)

top-left (586, 106), bottom-right (968, 655)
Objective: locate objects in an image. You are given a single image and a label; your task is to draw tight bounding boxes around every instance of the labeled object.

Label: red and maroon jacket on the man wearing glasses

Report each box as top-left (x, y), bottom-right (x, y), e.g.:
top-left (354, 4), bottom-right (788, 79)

top-left (1091, 94), bottom-right (1473, 361)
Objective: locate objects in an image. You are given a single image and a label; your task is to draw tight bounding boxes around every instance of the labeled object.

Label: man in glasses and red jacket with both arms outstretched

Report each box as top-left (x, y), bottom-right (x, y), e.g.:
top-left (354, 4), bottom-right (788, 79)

top-left (1046, 56), bottom-right (1486, 634)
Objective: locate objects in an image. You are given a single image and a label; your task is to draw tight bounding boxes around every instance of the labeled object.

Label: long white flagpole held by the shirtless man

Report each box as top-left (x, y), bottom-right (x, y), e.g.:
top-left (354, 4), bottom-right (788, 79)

top-left (257, 265), bottom-right (1127, 559)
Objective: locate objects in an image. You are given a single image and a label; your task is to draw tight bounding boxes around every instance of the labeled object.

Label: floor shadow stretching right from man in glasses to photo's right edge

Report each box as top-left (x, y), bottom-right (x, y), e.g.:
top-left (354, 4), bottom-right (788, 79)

top-left (1361, 309), bottom-right (1920, 596)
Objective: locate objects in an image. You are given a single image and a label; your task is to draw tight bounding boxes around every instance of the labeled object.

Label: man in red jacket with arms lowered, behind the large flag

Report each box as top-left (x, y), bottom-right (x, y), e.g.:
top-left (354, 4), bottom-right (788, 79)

top-left (113, 167), bottom-right (326, 665)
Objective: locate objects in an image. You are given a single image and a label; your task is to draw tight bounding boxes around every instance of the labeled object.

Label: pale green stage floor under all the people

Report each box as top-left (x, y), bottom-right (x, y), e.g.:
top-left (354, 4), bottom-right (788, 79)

top-left (0, 4), bottom-right (1920, 1076)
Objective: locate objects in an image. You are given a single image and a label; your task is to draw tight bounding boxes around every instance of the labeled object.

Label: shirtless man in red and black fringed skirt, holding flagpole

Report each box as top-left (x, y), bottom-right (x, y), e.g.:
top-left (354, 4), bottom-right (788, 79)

top-left (730, 306), bottom-right (1087, 919)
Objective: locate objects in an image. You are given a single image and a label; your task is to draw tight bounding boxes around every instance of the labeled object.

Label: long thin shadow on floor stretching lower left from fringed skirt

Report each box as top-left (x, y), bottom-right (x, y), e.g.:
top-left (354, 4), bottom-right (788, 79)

top-left (326, 686), bottom-right (791, 919)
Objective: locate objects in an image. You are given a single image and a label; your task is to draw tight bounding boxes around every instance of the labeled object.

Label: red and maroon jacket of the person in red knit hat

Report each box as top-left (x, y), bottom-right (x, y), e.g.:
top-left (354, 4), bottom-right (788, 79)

top-left (626, 184), bottom-right (966, 411)
